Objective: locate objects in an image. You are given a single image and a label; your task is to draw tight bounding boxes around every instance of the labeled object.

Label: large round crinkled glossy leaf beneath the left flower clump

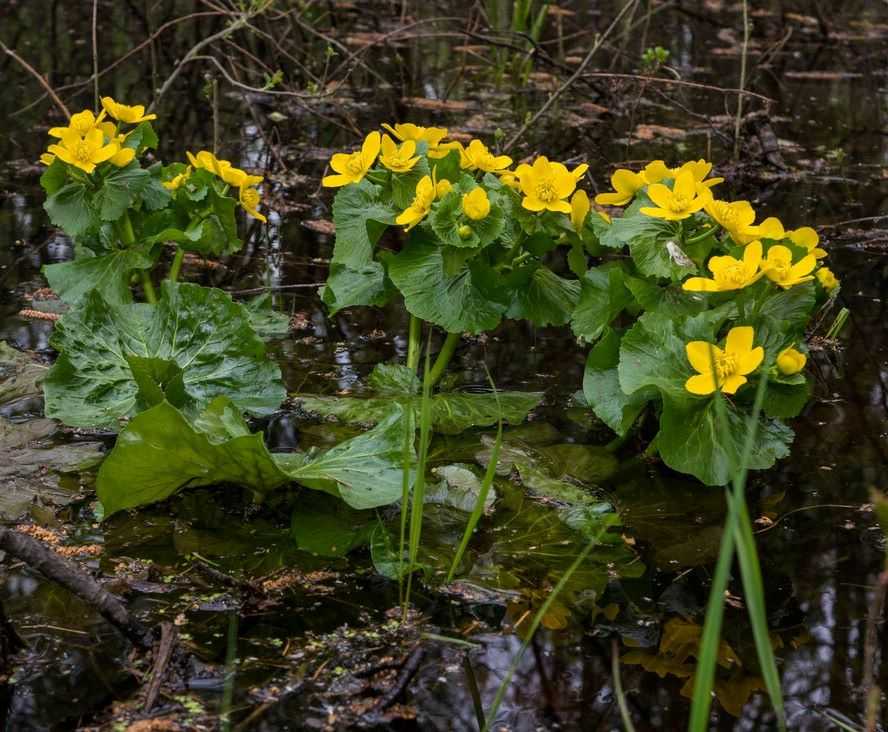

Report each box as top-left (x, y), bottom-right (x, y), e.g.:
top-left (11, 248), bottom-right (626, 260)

top-left (44, 281), bottom-right (285, 427)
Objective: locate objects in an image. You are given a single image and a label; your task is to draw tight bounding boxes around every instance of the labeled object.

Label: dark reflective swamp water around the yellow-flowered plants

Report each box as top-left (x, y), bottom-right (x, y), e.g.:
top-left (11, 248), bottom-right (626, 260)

top-left (0, 0), bottom-right (888, 730)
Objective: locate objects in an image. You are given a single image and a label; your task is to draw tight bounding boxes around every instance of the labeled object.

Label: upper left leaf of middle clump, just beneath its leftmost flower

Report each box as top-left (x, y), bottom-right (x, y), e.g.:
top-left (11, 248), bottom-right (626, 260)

top-left (333, 180), bottom-right (398, 269)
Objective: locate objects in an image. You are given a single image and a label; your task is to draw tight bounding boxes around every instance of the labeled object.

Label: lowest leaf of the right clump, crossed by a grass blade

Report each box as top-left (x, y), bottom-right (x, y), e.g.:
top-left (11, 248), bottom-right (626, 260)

top-left (657, 395), bottom-right (793, 485)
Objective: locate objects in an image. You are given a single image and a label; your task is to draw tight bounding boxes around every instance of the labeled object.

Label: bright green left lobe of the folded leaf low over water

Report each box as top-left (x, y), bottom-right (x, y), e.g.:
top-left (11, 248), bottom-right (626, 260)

top-left (96, 397), bottom-right (289, 516)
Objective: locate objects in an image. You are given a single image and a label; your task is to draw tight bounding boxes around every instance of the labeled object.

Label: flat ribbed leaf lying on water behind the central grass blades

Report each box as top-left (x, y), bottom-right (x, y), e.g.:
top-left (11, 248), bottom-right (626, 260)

top-left (295, 364), bottom-right (542, 434)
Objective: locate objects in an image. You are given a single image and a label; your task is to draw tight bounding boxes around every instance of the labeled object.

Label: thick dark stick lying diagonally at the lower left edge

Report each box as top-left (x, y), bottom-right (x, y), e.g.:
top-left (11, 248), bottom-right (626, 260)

top-left (0, 527), bottom-right (152, 649)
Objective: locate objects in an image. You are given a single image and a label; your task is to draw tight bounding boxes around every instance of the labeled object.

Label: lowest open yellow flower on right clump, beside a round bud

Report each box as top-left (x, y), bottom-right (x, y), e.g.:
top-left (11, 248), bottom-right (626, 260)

top-left (685, 325), bottom-right (765, 396)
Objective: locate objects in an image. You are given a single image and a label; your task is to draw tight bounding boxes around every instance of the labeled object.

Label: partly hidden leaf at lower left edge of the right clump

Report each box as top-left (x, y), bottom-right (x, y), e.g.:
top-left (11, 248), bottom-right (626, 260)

top-left (583, 328), bottom-right (658, 436)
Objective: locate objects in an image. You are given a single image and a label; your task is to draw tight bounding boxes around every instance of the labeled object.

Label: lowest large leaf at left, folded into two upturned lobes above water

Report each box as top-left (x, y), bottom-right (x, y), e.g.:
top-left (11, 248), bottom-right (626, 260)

top-left (96, 397), bottom-right (412, 515)
